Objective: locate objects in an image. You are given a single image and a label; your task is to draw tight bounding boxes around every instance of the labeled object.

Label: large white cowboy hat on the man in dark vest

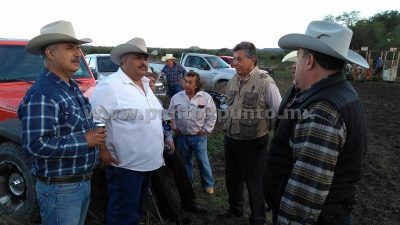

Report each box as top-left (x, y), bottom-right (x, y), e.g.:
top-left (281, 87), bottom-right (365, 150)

top-left (278, 21), bottom-right (369, 68)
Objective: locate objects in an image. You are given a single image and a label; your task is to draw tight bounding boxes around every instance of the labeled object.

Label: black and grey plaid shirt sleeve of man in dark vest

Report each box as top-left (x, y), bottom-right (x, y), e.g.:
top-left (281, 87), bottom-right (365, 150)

top-left (277, 102), bottom-right (347, 224)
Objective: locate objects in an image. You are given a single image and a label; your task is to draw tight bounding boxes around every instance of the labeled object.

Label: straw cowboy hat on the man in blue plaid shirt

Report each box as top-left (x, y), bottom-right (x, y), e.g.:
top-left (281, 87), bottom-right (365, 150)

top-left (26, 20), bottom-right (92, 55)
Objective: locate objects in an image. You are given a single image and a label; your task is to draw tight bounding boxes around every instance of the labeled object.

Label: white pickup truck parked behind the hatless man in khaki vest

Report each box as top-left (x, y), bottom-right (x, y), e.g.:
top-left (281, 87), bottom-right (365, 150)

top-left (149, 53), bottom-right (236, 94)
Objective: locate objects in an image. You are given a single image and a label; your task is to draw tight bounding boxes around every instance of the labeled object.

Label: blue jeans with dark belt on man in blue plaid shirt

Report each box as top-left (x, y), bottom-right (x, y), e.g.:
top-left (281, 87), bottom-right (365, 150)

top-left (36, 180), bottom-right (90, 225)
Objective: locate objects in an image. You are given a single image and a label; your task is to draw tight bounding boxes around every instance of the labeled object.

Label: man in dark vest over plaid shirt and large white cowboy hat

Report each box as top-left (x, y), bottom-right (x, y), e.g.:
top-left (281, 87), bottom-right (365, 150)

top-left (264, 21), bottom-right (368, 225)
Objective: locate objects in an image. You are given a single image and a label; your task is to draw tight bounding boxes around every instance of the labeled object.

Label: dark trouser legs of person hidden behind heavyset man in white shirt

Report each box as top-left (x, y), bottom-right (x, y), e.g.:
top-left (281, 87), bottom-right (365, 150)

top-left (151, 152), bottom-right (195, 218)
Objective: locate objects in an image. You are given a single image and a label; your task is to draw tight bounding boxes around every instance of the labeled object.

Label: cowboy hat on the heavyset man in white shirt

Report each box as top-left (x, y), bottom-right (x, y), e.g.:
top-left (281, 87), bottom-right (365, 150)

top-left (110, 37), bottom-right (157, 65)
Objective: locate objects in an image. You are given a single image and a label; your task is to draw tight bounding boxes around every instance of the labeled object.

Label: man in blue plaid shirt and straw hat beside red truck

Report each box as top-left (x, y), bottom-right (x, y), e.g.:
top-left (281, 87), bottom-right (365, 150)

top-left (18, 21), bottom-right (106, 225)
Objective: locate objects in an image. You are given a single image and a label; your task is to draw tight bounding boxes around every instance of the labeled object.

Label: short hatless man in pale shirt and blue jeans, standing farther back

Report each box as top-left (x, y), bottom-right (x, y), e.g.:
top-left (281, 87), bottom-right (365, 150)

top-left (168, 71), bottom-right (217, 194)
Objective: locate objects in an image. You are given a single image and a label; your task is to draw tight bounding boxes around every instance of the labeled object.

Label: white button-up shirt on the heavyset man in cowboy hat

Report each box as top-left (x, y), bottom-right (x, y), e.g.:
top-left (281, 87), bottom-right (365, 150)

top-left (90, 69), bottom-right (164, 171)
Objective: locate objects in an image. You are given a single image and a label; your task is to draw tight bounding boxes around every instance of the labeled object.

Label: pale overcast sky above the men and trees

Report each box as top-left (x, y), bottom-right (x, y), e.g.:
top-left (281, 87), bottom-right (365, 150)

top-left (0, 0), bottom-right (400, 49)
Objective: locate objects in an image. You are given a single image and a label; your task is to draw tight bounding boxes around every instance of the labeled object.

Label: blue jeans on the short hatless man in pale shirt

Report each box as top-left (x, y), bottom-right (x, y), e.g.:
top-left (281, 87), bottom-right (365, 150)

top-left (176, 134), bottom-right (214, 188)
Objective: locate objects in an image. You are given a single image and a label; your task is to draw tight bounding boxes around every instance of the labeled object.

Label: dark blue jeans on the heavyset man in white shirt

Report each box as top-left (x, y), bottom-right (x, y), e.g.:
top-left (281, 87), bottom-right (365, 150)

top-left (106, 166), bottom-right (151, 225)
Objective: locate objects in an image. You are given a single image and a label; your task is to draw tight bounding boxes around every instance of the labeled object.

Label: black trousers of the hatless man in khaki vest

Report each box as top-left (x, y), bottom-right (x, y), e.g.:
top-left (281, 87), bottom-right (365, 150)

top-left (224, 135), bottom-right (268, 224)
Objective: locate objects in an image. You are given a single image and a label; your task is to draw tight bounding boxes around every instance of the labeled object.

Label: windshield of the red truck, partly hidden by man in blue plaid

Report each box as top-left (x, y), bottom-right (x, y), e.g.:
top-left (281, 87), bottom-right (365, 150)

top-left (0, 45), bottom-right (90, 81)
